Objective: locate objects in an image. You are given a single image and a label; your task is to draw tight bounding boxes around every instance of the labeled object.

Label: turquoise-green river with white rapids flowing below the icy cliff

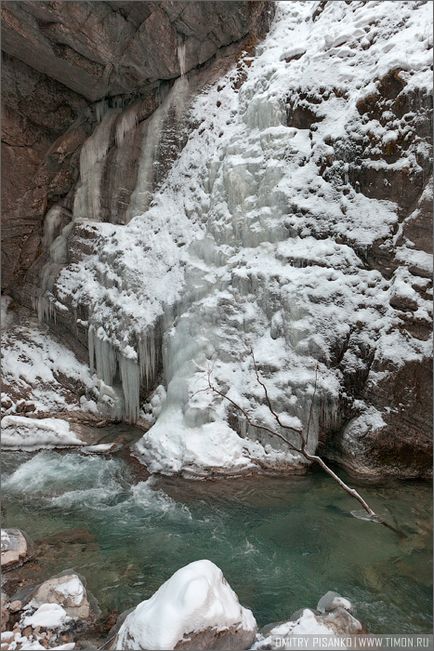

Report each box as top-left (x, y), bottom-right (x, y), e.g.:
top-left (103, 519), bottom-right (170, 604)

top-left (2, 451), bottom-right (432, 633)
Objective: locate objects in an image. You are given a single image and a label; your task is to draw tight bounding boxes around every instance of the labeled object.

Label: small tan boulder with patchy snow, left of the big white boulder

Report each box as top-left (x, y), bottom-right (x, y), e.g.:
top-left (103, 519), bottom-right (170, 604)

top-left (30, 572), bottom-right (91, 620)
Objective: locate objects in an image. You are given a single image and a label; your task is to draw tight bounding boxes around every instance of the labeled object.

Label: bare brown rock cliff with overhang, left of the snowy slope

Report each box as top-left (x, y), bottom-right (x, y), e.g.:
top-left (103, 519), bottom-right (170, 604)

top-left (2, 1), bottom-right (272, 296)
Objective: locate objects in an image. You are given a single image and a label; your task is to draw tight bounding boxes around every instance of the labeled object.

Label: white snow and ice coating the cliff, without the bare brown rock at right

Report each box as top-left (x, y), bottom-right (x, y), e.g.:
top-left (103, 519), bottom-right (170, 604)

top-left (41, 2), bottom-right (432, 472)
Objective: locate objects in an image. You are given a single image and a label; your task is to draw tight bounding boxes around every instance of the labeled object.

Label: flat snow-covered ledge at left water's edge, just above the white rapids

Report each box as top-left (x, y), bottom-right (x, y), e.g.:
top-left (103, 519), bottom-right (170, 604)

top-left (1, 416), bottom-right (84, 451)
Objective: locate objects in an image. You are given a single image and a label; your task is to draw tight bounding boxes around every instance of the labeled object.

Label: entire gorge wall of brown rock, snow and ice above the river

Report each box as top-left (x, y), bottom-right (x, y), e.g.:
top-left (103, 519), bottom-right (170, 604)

top-left (2, 2), bottom-right (432, 477)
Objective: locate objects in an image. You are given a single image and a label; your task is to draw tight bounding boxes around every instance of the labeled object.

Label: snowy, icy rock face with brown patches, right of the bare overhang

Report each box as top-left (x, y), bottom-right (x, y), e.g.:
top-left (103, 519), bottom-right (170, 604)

top-left (39, 2), bottom-right (432, 476)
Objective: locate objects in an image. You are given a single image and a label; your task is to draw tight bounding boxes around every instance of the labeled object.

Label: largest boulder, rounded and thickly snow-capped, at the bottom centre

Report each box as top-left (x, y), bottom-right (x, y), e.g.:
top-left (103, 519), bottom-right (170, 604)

top-left (111, 560), bottom-right (256, 651)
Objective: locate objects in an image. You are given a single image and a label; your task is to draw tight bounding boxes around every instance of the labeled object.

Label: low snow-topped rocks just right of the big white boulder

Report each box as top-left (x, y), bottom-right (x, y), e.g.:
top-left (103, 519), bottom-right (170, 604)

top-left (252, 591), bottom-right (363, 650)
